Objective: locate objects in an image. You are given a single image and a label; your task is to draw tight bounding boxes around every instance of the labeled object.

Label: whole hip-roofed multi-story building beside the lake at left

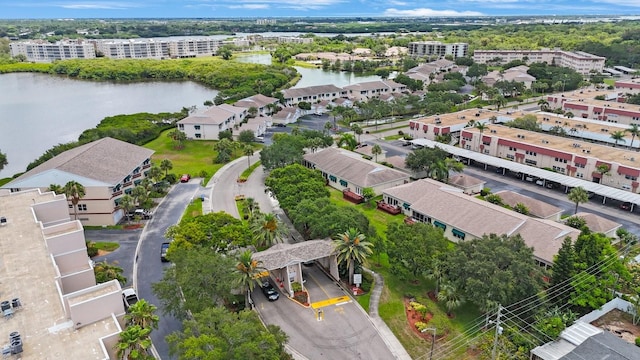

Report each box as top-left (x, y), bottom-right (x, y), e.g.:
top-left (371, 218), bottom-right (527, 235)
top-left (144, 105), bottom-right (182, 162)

top-left (0, 138), bottom-right (153, 225)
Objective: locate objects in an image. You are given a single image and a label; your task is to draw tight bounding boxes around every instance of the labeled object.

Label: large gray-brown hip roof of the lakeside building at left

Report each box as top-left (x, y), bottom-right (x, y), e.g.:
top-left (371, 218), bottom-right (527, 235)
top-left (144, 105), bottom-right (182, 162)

top-left (3, 137), bottom-right (154, 188)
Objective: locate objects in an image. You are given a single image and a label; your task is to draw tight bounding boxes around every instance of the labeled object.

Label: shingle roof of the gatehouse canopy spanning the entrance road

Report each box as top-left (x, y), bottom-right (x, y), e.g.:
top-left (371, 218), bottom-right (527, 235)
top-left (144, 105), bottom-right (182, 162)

top-left (252, 239), bottom-right (335, 270)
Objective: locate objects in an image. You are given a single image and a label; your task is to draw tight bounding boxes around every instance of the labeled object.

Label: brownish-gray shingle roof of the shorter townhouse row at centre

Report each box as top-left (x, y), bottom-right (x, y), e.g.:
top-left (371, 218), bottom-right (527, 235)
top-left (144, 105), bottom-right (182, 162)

top-left (304, 148), bottom-right (409, 188)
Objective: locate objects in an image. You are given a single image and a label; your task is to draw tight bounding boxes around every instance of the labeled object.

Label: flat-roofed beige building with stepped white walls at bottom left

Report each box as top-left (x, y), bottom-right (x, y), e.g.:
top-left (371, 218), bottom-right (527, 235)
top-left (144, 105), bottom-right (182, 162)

top-left (0, 189), bottom-right (125, 360)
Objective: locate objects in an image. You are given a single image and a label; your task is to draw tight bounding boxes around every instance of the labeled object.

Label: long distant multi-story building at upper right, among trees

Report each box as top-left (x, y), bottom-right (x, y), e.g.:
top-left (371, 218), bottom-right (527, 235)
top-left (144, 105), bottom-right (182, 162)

top-left (473, 49), bottom-right (606, 75)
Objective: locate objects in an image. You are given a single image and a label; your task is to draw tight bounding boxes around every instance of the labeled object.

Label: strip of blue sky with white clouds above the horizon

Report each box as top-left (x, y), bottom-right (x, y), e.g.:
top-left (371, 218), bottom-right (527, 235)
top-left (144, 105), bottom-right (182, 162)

top-left (0, 0), bottom-right (640, 19)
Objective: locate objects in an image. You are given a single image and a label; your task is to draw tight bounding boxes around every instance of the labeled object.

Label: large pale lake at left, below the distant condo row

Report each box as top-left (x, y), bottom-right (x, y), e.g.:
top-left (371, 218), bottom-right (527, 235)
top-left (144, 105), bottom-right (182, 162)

top-left (0, 73), bottom-right (217, 178)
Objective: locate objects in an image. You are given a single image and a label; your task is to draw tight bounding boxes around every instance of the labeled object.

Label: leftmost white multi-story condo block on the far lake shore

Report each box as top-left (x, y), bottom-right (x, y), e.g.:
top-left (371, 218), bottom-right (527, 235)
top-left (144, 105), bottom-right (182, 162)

top-left (9, 40), bottom-right (96, 62)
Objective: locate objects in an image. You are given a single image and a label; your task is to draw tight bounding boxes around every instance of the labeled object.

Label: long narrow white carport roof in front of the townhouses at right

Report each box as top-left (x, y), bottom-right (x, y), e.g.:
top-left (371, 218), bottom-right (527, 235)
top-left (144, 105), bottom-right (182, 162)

top-left (411, 139), bottom-right (640, 211)
